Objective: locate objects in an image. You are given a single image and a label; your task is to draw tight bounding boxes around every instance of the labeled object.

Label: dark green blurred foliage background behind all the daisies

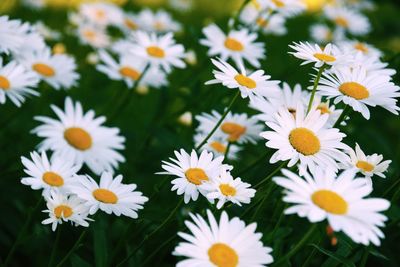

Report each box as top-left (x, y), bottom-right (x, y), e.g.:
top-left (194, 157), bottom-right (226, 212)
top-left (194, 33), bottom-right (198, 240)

top-left (0, 0), bottom-right (400, 267)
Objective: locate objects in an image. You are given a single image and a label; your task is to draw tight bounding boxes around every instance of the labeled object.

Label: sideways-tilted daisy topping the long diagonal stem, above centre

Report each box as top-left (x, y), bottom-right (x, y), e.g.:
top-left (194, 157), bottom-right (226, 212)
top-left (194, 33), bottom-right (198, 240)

top-left (206, 59), bottom-right (279, 99)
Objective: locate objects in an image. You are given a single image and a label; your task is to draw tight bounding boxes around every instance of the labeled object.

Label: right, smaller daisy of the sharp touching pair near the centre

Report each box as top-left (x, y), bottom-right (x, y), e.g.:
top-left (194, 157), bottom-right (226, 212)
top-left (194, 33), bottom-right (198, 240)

top-left (201, 171), bottom-right (256, 209)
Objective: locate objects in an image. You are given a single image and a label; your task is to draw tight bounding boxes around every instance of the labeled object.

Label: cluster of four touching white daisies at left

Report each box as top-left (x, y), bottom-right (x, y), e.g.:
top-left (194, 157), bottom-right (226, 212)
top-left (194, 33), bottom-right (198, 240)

top-left (21, 98), bottom-right (148, 231)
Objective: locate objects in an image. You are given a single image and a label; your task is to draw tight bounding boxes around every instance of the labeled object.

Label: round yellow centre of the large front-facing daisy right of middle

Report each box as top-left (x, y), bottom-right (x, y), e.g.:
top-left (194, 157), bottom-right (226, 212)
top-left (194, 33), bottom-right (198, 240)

top-left (289, 128), bottom-right (321, 156)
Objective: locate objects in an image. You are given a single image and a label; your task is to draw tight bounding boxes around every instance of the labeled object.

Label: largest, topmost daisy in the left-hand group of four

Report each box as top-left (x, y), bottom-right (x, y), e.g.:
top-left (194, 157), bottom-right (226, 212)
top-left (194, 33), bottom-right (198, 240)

top-left (32, 97), bottom-right (125, 174)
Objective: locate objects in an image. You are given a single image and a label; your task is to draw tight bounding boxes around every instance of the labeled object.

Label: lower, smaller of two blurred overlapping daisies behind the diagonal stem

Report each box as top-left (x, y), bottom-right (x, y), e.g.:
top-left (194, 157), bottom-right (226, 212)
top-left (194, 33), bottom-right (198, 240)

top-left (194, 133), bottom-right (241, 160)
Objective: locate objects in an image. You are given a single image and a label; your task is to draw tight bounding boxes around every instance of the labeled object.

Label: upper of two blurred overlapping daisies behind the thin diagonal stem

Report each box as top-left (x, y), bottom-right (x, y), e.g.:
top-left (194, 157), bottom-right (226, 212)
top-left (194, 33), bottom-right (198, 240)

top-left (195, 110), bottom-right (264, 144)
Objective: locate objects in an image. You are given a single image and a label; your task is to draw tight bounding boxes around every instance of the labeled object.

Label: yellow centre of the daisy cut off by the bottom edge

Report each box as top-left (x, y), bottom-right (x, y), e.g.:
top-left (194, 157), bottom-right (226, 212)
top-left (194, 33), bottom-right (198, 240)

top-left (208, 243), bottom-right (239, 267)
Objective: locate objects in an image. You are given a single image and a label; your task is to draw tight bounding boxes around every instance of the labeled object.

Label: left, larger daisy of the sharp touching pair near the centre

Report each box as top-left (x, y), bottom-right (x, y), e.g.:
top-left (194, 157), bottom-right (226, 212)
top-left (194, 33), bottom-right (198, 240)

top-left (157, 149), bottom-right (232, 203)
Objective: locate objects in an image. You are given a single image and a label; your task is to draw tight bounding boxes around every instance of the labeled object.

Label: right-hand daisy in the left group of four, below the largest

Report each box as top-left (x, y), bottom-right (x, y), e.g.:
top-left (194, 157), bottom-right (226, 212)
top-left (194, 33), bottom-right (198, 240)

top-left (69, 172), bottom-right (149, 219)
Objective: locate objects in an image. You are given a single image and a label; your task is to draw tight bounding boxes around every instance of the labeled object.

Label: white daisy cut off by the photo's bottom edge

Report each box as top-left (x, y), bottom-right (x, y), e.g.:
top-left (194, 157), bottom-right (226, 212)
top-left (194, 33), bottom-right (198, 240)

top-left (173, 210), bottom-right (273, 267)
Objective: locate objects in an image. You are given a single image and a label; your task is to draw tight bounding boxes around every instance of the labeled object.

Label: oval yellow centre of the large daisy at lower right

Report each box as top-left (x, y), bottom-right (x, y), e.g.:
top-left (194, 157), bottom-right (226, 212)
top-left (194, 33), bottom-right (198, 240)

top-left (311, 190), bottom-right (348, 215)
